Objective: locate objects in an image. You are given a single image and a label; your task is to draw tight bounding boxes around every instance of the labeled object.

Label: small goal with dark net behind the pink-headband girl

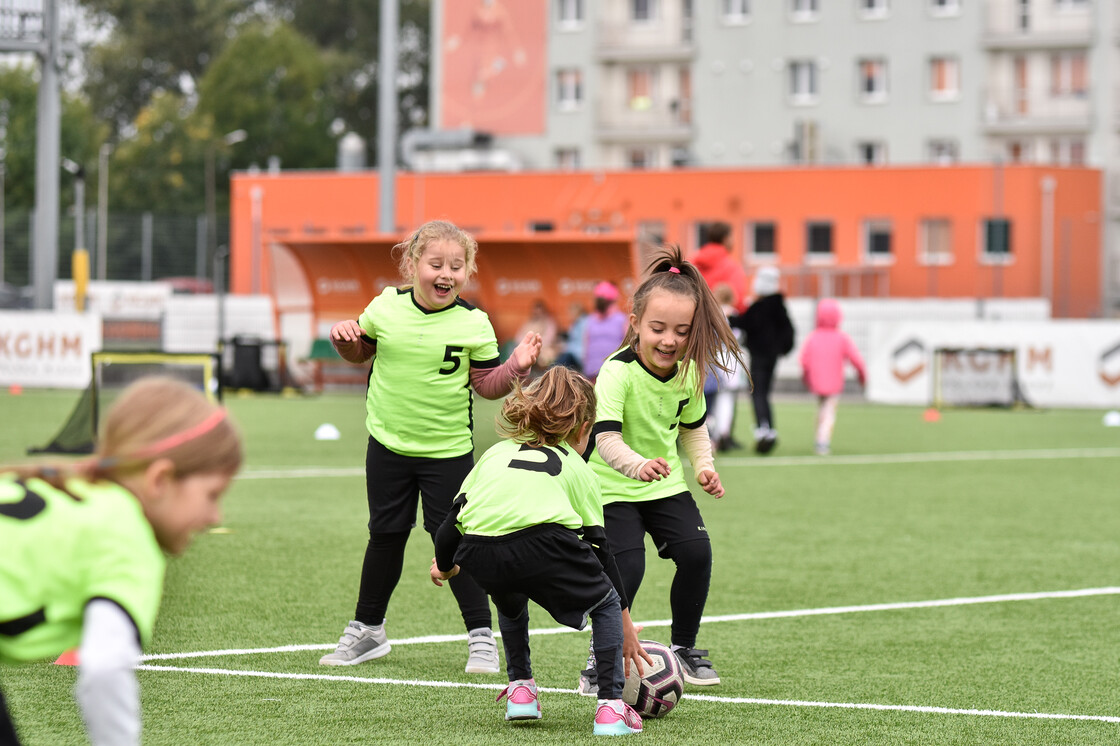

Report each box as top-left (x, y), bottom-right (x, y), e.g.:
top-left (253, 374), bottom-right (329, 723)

top-left (27, 352), bottom-right (222, 454)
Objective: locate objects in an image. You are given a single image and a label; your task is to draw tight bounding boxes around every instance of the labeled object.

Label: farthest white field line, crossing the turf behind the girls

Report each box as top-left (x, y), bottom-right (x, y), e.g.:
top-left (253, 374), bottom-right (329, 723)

top-left (237, 448), bottom-right (1120, 479)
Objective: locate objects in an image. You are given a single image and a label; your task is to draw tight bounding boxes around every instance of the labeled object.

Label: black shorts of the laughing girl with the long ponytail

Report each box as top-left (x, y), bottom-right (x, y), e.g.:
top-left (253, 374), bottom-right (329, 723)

top-left (603, 492), bottom-right (711, 558)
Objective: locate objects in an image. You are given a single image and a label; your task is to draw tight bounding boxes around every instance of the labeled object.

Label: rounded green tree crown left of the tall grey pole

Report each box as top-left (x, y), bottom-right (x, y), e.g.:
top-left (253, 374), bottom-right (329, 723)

top-left (198, 22), bottom-right (335, 168)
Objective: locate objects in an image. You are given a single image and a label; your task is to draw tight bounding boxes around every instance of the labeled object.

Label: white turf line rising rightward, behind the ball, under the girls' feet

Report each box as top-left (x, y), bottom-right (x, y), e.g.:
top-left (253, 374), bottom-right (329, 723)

top-left (140, 587), bottom-right (1120, 661)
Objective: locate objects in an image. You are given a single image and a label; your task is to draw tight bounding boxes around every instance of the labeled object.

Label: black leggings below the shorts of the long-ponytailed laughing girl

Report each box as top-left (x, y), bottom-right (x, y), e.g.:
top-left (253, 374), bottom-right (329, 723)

top-left (615, 540), bottom-right (711, 647)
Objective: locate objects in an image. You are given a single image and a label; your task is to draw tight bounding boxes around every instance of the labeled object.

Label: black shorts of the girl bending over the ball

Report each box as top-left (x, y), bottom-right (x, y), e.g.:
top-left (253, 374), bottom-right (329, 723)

top-left (455, 523), bottom-right (615, 630)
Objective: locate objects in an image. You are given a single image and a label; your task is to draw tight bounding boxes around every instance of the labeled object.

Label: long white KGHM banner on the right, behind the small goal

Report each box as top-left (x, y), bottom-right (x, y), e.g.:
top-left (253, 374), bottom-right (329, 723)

top-left (867, 320), bottom-right (1120, 409)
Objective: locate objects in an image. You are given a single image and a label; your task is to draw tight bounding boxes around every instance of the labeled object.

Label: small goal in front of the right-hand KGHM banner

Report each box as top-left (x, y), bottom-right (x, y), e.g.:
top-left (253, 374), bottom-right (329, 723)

top-left (932, 347), bottom-right (1028, 407)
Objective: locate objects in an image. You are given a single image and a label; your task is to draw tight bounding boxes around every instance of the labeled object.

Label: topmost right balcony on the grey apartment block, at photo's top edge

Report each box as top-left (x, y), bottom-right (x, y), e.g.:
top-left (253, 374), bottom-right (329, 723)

top-left (982, 0), bottom-right (1094, 52)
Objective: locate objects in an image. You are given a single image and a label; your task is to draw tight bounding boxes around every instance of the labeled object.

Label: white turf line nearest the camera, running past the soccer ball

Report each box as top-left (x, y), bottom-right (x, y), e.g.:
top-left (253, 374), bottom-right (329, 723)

top-left (137, 665), bottom-right (1120, 722)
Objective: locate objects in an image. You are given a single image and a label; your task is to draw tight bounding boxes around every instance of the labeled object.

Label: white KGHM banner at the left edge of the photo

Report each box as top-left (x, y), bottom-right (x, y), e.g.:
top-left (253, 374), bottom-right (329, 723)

top-left (0, 311), bottom-right (101, 389)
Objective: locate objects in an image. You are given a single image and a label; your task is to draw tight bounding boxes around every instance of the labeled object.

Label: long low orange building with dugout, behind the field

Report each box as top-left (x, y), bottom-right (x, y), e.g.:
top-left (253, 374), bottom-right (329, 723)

top-left (231, 166), bottom-right (1102, 338)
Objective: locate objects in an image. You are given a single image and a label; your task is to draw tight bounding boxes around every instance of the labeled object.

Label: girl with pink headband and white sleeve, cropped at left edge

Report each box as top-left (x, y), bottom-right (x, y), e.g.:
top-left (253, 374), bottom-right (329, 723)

top-left (0, 377), bottom-right (242, 745)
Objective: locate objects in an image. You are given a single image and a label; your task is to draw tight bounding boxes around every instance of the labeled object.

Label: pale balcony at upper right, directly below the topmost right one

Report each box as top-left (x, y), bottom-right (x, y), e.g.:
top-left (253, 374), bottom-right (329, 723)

top-left (980, 86), bottom-right (1093, 134)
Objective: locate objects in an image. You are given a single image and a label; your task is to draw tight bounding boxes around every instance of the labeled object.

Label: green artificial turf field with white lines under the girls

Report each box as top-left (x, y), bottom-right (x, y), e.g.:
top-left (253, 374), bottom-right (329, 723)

top-left (0, 391), bottom-right (1120, 745)
